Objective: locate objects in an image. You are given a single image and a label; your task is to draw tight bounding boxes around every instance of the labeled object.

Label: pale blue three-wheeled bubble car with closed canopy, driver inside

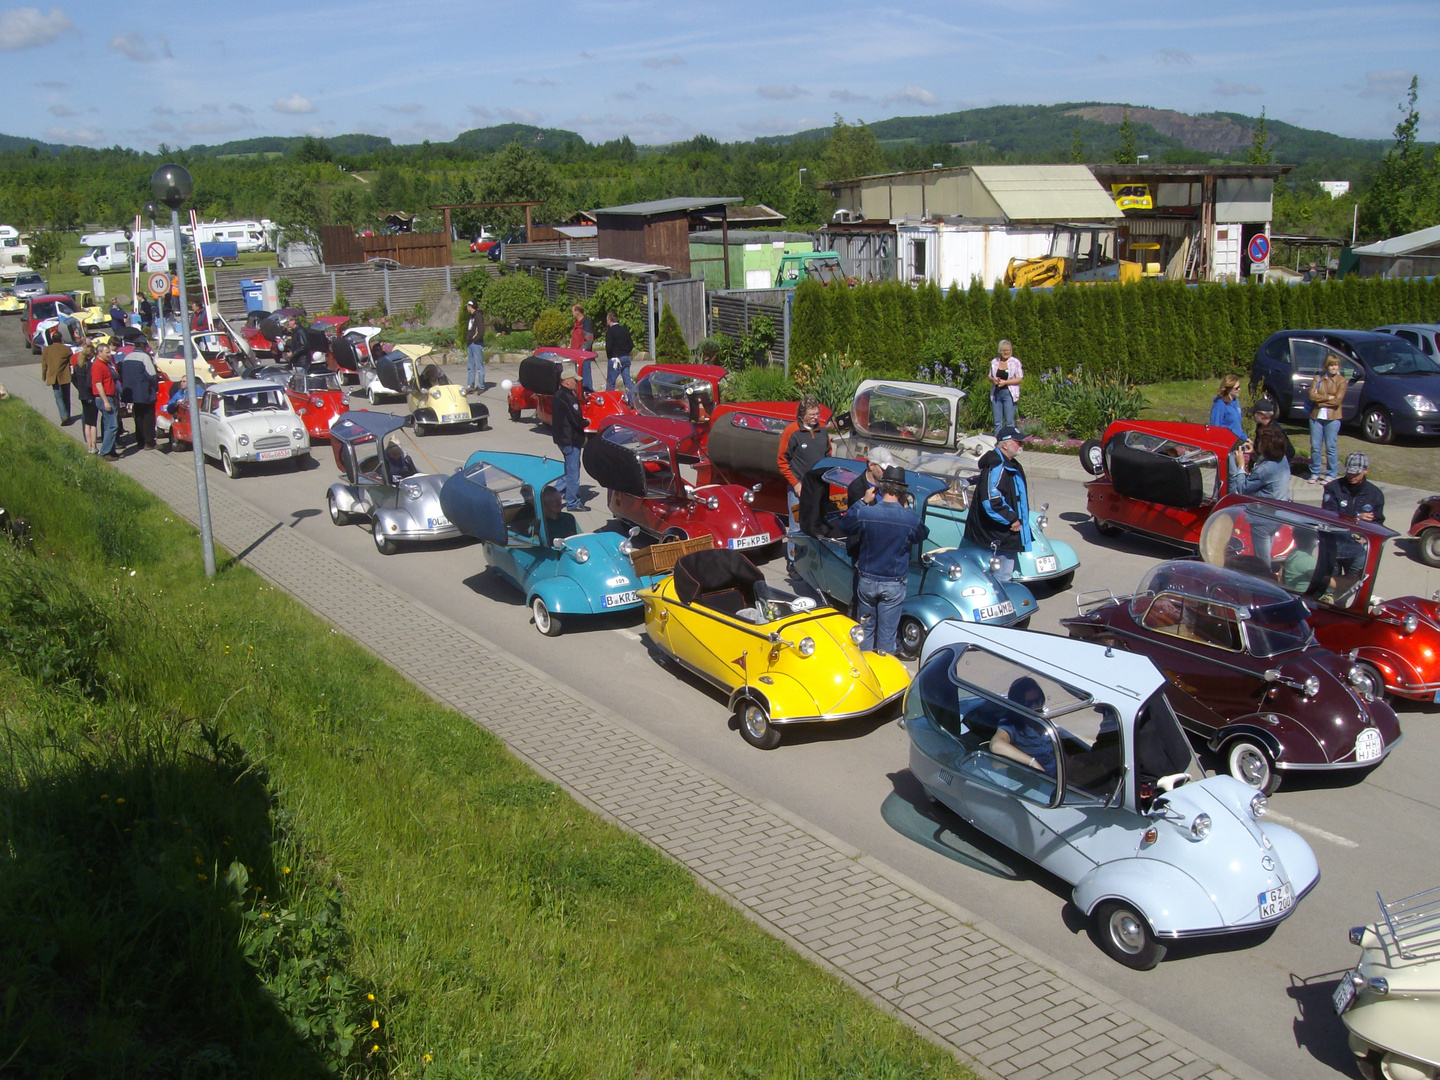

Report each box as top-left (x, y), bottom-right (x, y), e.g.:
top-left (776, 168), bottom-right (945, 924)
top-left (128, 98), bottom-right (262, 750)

top-left (901, 621), bottom-right (1320, 971)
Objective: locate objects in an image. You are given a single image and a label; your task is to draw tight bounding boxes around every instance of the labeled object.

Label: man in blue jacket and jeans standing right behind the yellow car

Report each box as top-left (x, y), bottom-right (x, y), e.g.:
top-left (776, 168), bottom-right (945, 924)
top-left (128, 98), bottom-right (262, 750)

top-left (841, 465), bottom-right (930, 655)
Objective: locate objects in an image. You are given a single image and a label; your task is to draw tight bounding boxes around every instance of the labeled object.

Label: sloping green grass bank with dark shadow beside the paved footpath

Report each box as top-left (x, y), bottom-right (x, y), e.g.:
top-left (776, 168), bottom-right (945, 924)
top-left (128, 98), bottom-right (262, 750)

top-left (0, 399), bottom-right (966, 1077)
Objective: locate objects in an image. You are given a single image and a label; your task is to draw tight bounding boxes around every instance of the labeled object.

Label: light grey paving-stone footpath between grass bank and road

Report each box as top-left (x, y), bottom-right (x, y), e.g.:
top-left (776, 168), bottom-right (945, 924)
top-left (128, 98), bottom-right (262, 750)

top-left (10, 377), bottom-right (1264, 1080)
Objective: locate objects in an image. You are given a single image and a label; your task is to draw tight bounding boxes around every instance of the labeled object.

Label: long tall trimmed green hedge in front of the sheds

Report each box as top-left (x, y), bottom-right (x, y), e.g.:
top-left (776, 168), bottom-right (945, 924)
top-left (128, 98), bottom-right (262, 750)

top-left (791, 275), bottom-right (1440, 383)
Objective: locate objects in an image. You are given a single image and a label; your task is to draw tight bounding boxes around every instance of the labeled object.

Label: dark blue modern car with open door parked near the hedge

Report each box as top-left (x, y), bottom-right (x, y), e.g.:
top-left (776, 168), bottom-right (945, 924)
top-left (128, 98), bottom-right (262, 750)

top-left (1250, 330), bottom-right (1440, 442)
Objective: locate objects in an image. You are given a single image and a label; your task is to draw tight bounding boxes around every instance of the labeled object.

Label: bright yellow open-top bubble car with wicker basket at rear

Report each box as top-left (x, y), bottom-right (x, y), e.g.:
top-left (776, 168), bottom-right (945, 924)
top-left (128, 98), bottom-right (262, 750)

top-left (639, 549), bottom-right (910, 750)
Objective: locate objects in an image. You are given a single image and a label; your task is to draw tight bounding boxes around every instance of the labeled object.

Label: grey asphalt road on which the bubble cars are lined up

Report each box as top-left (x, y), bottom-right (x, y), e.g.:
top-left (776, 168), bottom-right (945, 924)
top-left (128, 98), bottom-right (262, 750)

top-left (0, 327), bottom-right (1440, 1077)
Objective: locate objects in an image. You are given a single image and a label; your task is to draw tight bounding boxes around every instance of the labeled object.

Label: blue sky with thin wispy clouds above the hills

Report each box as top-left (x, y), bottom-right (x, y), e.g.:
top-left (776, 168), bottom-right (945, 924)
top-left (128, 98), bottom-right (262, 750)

top-left (0, 0), bottom-right (1440, 150)
